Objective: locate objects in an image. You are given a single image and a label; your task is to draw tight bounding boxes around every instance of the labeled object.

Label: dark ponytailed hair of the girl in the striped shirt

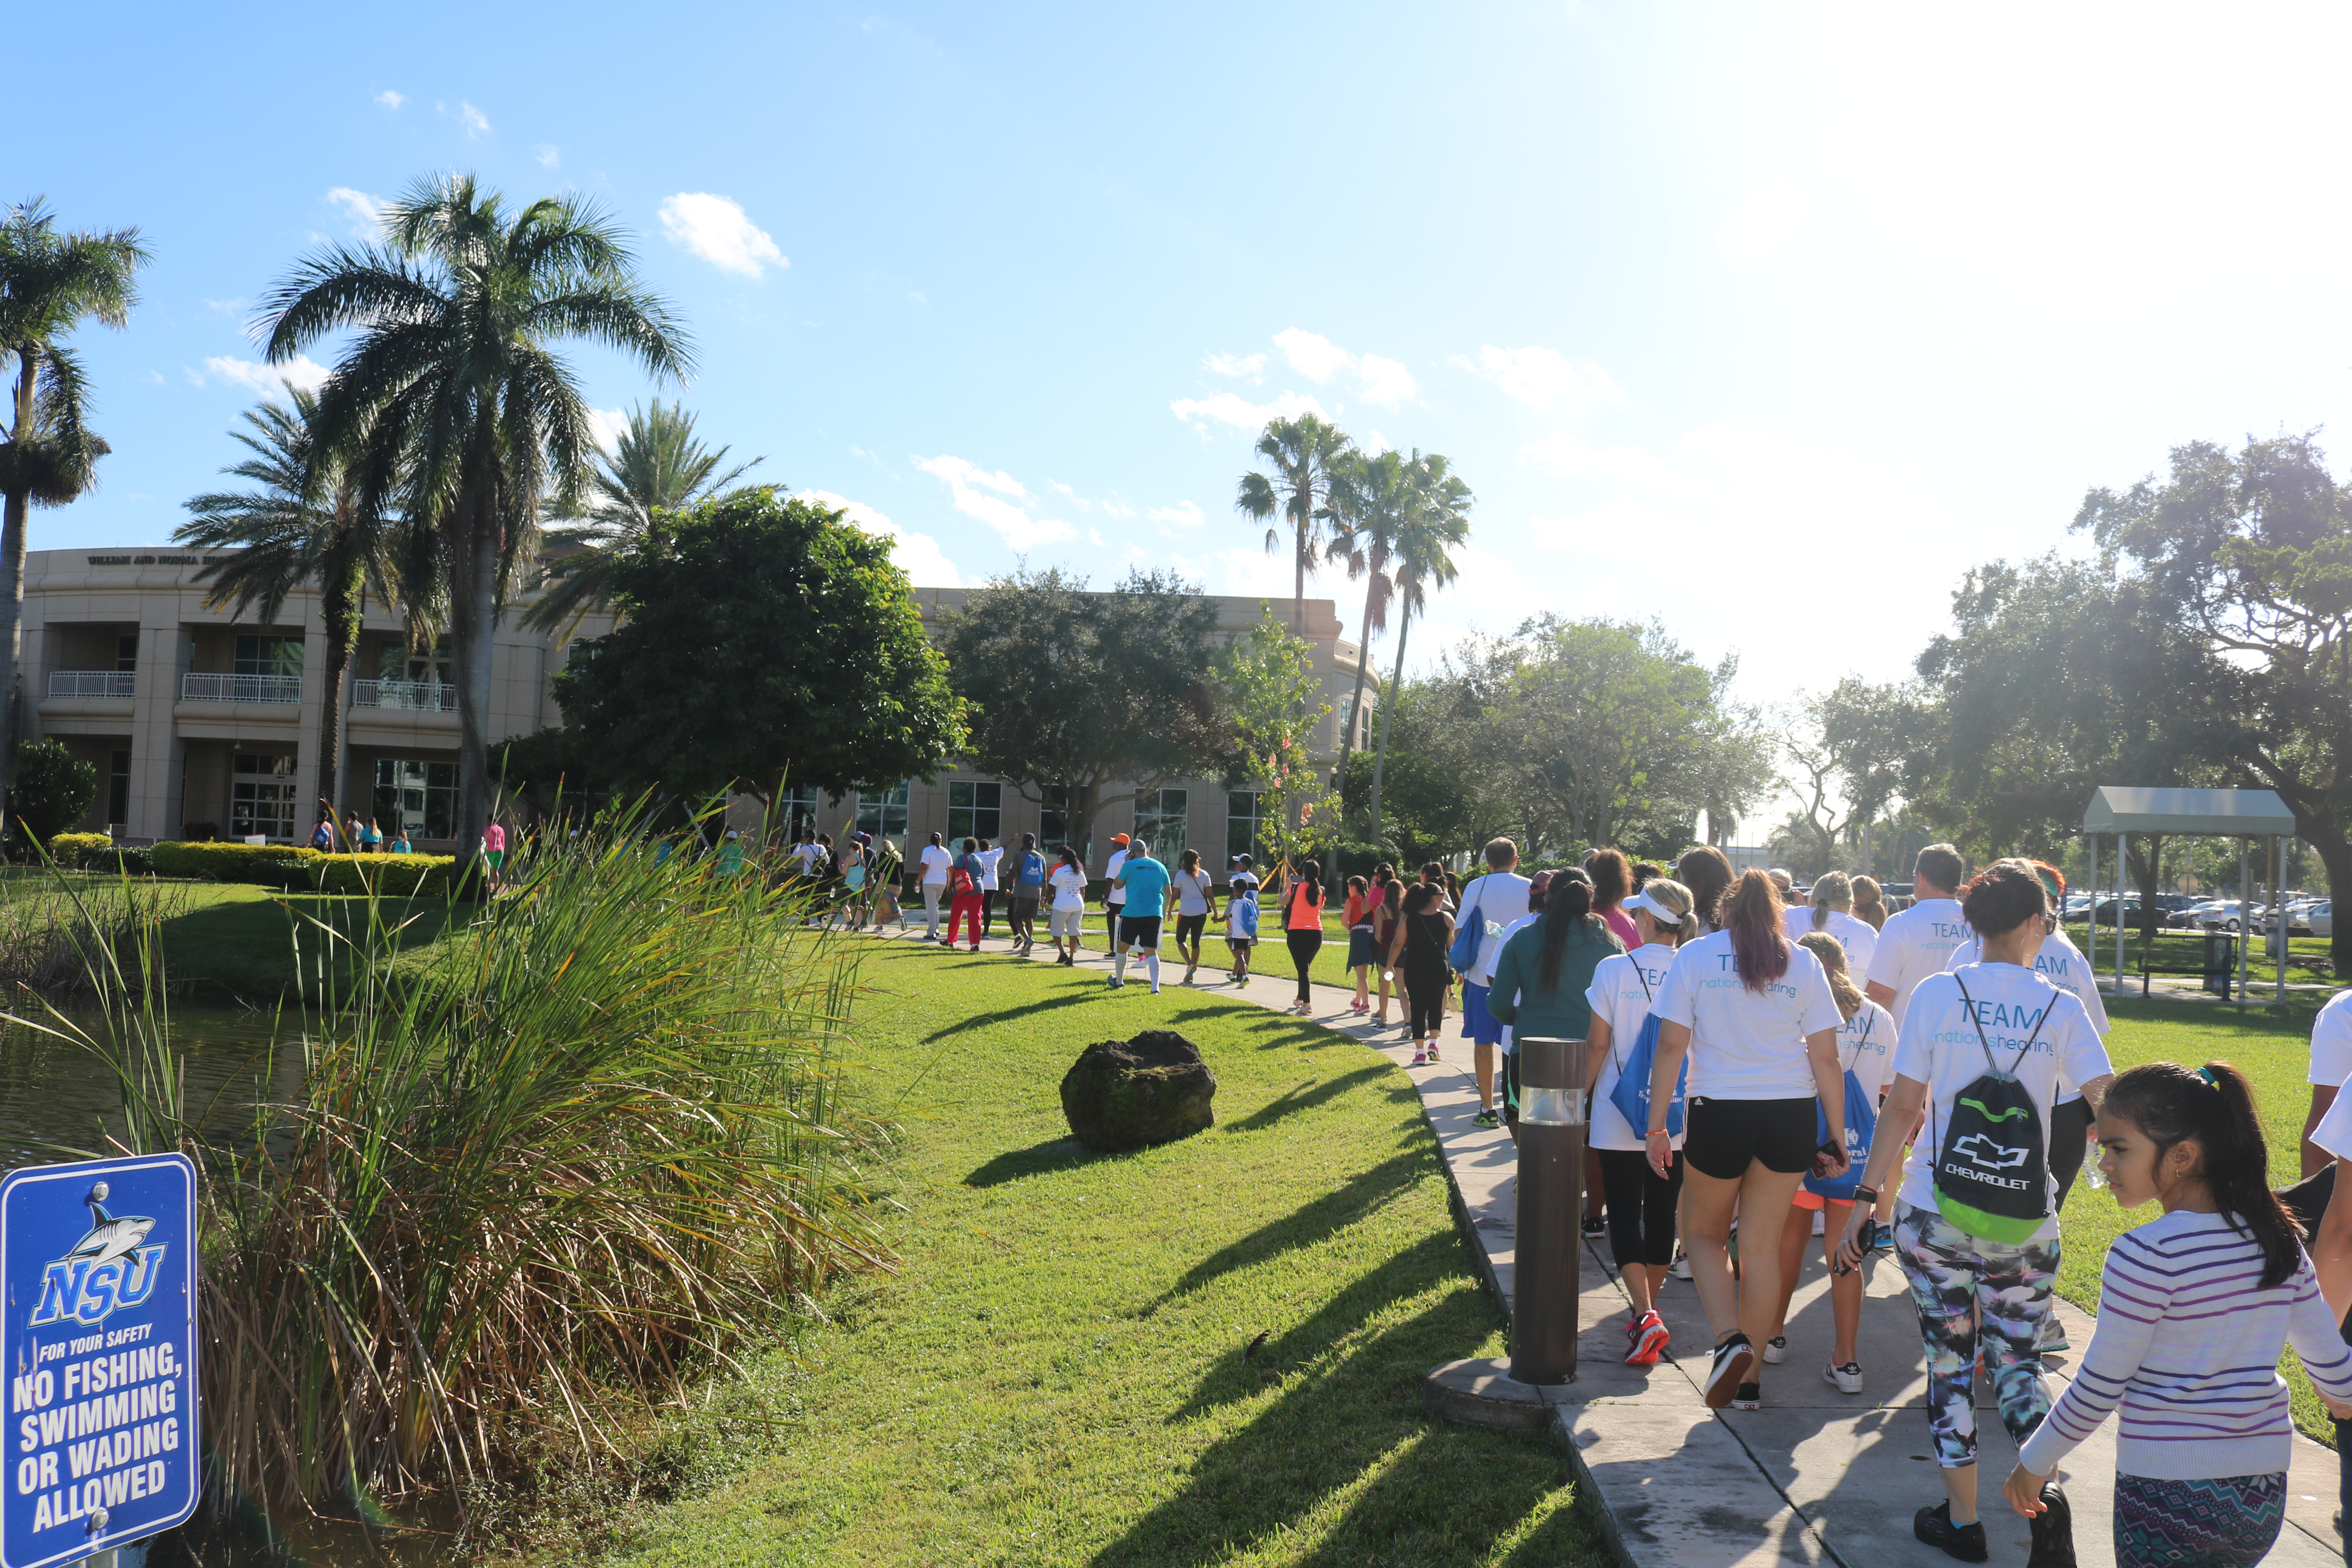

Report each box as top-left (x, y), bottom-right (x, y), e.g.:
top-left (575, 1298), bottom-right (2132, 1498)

top-left (2100, 1063), bottom-right (2303, 1290)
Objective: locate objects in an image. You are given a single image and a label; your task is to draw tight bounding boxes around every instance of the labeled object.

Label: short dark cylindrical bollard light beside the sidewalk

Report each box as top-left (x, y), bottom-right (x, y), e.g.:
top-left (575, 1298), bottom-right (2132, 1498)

top-left (1510, 1037), bottom-right (1585, 1385)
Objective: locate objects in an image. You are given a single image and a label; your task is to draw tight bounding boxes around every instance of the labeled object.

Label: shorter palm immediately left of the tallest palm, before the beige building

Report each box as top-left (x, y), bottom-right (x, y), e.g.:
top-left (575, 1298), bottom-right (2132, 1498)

top-left (172, 388), bottom-right (430, 820)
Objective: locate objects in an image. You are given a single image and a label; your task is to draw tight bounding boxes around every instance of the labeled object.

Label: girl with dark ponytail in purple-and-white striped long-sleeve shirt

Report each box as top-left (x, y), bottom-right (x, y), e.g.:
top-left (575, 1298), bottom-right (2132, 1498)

top-left (2009, 1063), bottom-right (2352, 1568)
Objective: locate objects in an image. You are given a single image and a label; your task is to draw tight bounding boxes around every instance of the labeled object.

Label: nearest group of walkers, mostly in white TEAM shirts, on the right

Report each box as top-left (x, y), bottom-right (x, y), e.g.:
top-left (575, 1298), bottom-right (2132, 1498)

top-left (1468, 842), bottom-right (2352, 1568)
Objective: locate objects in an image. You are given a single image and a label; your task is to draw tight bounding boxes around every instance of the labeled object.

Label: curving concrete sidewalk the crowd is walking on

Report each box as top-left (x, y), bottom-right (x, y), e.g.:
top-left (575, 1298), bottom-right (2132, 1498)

top-left (894, 926), bottom-right (2345, 1568)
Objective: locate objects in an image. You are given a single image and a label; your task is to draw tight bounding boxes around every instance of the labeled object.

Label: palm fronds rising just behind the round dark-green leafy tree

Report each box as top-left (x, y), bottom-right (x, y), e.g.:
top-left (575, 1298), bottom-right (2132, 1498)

top-left (522, 397), bottom-right (767, 635)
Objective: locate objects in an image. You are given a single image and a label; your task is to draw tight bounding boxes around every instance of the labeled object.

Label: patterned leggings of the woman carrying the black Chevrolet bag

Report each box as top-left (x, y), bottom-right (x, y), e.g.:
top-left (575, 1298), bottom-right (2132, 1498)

top-left (1896, 1203), bottom-right (2058, 1469)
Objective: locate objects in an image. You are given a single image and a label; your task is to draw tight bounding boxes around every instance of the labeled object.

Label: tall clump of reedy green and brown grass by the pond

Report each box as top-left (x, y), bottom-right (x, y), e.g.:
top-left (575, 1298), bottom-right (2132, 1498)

top-left (25, 813), bottom-right (884, 1509)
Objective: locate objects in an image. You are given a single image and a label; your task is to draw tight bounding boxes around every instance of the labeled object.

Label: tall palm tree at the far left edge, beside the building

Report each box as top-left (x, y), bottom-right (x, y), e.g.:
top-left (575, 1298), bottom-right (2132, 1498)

top-left (0, 198), bottom-right (148, 827)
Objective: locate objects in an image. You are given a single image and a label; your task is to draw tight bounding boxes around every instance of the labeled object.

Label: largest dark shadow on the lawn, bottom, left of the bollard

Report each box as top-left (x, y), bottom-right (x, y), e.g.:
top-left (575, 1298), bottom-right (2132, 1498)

top-left (1091, 1279), bottom-right (1599, 1568)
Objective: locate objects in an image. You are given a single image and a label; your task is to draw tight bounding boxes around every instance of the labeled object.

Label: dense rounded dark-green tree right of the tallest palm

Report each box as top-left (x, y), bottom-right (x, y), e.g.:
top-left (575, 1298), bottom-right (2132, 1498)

top-left (555, 486), bottom-right (964, 797)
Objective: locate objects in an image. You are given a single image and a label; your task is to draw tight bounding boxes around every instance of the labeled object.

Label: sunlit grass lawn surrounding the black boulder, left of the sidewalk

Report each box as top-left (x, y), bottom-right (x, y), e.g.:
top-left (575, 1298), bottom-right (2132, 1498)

top-left (572, 943), bottom-right (1604, 1568)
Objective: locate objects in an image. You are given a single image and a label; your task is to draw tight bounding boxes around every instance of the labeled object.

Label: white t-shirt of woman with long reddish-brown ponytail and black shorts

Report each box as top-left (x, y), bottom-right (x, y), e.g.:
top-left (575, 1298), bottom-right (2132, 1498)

top-left (1653, 931), bottom-right (1844, 1100)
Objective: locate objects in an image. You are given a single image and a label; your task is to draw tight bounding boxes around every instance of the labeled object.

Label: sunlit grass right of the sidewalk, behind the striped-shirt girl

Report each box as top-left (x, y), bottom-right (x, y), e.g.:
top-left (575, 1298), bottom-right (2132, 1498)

top-left (2058, 999), bottom-right (2336, 1443)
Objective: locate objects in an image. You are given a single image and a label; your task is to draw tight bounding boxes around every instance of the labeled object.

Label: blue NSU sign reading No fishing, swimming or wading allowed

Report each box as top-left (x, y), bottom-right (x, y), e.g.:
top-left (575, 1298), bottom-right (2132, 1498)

top-left (0, 1154), bottom-right (202, 1568)
